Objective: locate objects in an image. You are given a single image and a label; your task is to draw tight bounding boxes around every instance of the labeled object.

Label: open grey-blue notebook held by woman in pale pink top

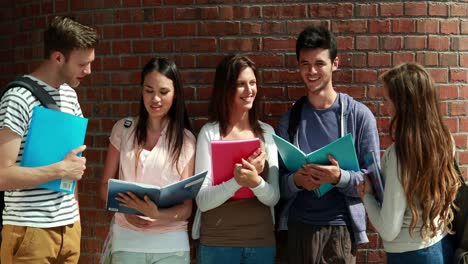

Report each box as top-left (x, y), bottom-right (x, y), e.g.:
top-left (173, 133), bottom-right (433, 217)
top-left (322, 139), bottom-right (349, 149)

top-left (106, 171), bottom-right (208, 215)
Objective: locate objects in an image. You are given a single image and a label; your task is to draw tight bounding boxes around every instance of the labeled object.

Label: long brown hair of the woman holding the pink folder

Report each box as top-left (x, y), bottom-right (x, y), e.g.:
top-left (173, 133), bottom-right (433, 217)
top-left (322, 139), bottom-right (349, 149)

top-left (209, 55), bottom-right (263, 139)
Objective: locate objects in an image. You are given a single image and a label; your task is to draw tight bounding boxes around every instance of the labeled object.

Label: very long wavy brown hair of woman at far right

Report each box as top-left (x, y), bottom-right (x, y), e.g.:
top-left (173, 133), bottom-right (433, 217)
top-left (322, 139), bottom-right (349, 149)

top-left (382, 63), bottom-right (460, 239)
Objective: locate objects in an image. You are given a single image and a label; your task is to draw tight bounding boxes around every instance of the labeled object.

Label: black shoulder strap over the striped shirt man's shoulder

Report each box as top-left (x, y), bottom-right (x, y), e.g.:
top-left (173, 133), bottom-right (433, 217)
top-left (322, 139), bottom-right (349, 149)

top-left (0, 76), bottom-right (60, 111)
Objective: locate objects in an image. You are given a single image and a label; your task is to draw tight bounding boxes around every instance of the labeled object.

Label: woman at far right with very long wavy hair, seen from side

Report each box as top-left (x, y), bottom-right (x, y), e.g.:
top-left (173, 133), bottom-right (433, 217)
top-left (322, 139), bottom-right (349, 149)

top-left (358, 63), bottom-right (460, 264)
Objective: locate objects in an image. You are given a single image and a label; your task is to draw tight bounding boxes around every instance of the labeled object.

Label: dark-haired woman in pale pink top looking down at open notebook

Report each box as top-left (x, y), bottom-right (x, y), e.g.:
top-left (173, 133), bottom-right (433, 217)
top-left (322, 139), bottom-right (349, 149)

top-left (100, 58), bottom-right (195, 264)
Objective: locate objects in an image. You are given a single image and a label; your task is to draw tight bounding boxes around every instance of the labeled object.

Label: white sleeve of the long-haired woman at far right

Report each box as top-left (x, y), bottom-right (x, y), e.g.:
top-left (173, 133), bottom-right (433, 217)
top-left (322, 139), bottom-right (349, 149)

top-left (363, 147), bottom-right (407, 241)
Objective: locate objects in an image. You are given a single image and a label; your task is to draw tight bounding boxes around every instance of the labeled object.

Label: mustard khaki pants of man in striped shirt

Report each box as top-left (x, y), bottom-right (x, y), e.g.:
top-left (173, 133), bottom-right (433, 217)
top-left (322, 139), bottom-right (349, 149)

top-left (0, 222), bottom-right (81, 264)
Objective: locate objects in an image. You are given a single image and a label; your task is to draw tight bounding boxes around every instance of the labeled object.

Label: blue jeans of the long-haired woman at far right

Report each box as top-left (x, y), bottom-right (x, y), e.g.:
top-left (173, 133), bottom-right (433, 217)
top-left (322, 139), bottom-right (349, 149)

top-left (387, 235), bottom-right (455, 264)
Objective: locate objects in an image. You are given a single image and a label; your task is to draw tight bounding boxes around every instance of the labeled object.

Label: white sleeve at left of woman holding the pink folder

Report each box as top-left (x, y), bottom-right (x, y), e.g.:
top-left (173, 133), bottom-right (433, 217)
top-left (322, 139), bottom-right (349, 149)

top-left (195, 124), bottom-right (241, 212)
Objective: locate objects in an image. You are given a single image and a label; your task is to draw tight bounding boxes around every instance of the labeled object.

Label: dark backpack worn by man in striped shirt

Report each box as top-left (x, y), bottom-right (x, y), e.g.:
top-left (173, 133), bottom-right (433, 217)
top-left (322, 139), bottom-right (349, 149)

top-left (0, 76), bottom-right (60, 234)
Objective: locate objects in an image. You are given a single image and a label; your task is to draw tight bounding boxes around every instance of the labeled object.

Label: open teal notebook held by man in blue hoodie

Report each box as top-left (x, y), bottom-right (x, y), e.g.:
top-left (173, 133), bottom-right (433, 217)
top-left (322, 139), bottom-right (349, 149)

top-left (273, 133), bottom-right (360, 197)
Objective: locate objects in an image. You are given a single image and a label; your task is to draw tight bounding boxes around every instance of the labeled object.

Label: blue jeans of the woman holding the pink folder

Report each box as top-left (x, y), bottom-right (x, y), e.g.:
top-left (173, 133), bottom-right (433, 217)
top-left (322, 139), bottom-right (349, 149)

top-left (197, 244), bottom-right (276, 264)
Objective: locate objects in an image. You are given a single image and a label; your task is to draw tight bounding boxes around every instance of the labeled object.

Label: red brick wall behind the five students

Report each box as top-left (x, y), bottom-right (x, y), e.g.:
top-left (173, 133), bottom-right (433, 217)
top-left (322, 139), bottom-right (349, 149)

top-left (0, 0), bottom-right (468, 263)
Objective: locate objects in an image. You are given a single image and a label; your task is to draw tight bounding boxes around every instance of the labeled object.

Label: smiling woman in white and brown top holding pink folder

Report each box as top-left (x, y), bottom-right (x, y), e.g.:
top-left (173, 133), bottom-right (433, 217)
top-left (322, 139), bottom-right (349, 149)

top-left (192, 55), bottom-right (279, 264)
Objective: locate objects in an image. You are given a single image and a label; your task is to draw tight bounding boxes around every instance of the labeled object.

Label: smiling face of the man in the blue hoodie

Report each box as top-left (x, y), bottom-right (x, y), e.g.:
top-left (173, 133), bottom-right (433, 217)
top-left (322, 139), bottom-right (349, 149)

top-left (299, 48), bottom-right (338, 94)
